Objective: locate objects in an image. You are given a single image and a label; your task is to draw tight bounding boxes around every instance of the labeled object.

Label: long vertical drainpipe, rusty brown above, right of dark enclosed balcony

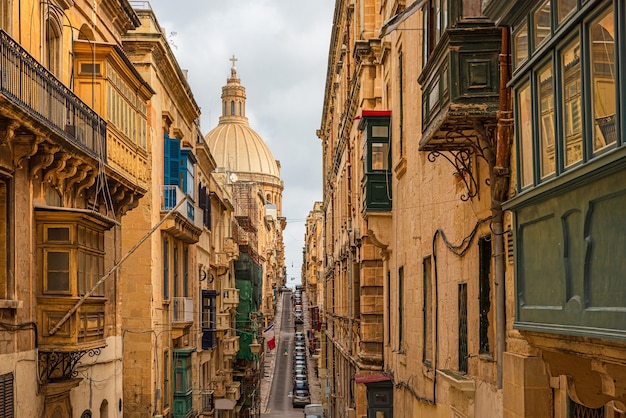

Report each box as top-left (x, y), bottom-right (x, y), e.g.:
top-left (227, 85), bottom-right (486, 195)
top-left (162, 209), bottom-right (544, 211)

top-left (491, 27), bottom-right (513, 389)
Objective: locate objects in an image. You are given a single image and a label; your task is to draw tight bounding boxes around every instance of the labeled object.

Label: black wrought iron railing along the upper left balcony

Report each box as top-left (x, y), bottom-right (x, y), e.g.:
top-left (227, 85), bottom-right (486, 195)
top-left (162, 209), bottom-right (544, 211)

top-left (0, 30), bottom-right (106, 162)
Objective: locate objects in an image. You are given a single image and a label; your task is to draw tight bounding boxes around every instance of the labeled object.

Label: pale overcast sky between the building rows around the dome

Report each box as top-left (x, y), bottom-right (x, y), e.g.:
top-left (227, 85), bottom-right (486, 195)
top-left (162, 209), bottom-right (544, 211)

top-left (150, 0), bottom-right (335, 286)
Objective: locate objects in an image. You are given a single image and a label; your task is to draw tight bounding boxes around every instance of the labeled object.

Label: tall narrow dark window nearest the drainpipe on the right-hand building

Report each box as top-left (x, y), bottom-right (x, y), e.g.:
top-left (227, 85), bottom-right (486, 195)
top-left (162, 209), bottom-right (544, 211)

top-left (478, 236), bottom-right (491, 354)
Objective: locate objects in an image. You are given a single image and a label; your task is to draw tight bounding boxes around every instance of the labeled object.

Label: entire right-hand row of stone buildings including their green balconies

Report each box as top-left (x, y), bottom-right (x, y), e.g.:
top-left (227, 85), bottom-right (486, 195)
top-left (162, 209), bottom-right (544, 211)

top-left (318, 0), bottom-right (625, 418)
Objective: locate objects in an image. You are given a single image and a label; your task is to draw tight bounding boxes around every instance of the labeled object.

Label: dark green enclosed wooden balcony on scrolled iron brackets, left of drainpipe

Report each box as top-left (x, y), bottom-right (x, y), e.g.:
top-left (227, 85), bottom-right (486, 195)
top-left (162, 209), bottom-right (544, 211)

top-left (418, 25), bottom-right (501, 151)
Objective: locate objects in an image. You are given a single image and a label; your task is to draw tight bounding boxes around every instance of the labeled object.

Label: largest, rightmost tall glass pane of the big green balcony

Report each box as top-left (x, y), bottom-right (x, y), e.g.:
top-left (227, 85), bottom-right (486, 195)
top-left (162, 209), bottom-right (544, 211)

top-left (590, 9), bottom-right (616, 152)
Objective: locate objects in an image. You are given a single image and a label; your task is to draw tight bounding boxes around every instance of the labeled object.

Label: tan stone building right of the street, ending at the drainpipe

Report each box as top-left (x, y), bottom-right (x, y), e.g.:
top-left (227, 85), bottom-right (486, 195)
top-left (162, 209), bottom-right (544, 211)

top-left (318, 0), bottom-right (511, 417)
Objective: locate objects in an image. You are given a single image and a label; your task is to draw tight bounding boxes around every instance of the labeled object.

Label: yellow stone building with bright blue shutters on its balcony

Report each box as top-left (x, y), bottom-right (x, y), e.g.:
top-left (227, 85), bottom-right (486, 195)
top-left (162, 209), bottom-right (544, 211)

top-left (123, 3), bottom-right (240, 417)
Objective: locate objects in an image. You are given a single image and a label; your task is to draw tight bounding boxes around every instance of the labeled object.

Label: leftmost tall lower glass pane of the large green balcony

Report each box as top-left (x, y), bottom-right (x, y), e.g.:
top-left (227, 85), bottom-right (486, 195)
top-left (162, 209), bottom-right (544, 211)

top-left (517, 85), bottom-right (533, 188)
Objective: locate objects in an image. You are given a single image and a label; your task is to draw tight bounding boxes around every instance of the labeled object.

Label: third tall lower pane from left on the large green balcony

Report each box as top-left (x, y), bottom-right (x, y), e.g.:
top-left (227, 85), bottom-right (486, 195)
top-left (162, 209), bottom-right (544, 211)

top-left (561, 40), bottom-right (583, 167)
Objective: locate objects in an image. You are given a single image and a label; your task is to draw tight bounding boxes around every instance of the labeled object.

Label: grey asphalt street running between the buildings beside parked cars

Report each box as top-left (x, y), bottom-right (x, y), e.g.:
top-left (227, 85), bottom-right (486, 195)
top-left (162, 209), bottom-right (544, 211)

top-left (262, 292), bottom-right (320, 418)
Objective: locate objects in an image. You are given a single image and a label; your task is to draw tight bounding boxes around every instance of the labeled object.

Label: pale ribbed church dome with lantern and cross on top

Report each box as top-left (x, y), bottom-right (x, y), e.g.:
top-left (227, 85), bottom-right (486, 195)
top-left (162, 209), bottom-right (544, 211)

top-left (205, 57), bottom-right (280, 178)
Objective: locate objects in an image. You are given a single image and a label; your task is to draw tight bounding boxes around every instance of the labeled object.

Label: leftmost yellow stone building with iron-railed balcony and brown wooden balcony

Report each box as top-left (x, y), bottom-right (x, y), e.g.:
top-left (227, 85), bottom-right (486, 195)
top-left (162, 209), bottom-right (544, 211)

top-left (0, 0), bottom-right (152, 417)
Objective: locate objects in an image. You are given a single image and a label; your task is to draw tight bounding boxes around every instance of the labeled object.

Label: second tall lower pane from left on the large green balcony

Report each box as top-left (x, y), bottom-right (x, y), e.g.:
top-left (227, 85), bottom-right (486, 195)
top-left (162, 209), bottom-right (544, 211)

top-left (537, 64), bottom-right (555, 178)
